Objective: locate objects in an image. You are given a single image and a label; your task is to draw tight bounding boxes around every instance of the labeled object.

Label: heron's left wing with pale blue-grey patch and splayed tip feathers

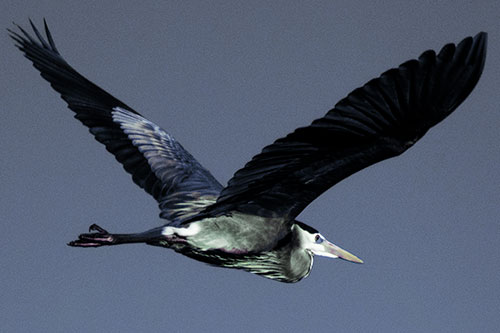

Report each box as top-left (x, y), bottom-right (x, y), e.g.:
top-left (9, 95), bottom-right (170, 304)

top-left (9, 21), bottom-right (222, 224)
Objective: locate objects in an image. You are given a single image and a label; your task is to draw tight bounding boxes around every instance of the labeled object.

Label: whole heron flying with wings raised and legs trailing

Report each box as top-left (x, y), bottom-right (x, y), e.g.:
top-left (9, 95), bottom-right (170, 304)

top-left (9, 20), bottom-right (487, 282)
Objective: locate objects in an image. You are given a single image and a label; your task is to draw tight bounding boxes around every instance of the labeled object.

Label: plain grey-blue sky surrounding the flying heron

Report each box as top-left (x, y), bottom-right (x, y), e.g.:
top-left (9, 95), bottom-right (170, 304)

top-left (0, 0), bottom-right (500, 332)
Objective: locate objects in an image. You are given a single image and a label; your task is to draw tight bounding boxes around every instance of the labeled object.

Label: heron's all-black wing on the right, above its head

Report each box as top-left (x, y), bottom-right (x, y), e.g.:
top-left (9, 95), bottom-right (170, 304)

top-left (204, 32), bottom-right (487, 220)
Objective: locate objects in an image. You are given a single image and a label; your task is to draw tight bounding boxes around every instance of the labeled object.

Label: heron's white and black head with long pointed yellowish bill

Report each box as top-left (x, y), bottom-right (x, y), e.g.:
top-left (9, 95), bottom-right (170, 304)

top-left (293, 221), bottom-right (363, 264)
